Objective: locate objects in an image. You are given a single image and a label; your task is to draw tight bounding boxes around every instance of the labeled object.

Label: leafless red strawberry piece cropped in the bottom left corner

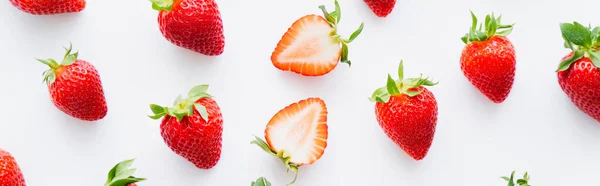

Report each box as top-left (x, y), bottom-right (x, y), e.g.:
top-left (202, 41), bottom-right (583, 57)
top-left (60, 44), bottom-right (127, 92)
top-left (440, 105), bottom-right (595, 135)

top-left (0, 149), bottom-right (25, 186)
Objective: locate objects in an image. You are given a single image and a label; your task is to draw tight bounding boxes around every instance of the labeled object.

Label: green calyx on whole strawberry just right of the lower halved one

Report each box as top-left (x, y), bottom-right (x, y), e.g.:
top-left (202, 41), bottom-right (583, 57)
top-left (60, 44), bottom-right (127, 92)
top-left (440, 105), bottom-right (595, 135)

top-left (369, 61), bottom-right (438, 103)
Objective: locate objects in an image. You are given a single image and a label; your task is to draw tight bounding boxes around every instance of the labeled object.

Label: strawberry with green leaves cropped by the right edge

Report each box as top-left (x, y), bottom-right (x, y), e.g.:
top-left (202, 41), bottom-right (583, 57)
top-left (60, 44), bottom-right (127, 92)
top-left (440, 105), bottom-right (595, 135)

top-left (557, 22), bottom-right (600, 121)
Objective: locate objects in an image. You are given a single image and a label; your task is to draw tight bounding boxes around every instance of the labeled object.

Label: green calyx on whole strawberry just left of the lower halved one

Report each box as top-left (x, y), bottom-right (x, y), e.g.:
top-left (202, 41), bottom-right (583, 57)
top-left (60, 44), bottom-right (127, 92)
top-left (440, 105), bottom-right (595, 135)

top-left (149, 85), bottom-right (212, 121)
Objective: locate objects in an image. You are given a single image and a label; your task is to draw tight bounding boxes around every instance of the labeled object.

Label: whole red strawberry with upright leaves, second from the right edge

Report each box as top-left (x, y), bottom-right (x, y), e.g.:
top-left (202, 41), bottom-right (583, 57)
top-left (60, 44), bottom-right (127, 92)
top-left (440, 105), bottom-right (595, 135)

top-left (460, 12), bottom-right (516, 103)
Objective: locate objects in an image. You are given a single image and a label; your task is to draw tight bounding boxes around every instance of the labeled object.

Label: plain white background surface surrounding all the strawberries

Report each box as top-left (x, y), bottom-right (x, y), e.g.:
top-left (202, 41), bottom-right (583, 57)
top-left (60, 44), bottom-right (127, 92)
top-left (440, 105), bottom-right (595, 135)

top-left (0, 0), bottom-right (600, 186)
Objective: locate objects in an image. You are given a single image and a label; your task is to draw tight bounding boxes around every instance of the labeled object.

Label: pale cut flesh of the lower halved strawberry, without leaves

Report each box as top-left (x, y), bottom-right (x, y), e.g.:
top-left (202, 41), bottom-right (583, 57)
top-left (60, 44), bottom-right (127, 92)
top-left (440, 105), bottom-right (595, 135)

top-left (268, 103), bottom-right (327, 164)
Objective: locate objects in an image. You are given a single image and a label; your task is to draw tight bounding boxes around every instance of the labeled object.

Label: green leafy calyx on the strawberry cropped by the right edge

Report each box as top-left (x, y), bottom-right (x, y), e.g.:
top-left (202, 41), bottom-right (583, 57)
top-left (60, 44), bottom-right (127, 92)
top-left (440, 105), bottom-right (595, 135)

top-left (556, 22), bottom-right (600, 72)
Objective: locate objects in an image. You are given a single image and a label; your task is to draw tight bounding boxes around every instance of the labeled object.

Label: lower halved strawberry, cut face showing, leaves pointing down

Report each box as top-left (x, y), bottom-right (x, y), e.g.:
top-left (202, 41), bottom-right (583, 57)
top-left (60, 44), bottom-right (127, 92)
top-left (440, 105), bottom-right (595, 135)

top-left (251, 98), bottom-right (328, 185)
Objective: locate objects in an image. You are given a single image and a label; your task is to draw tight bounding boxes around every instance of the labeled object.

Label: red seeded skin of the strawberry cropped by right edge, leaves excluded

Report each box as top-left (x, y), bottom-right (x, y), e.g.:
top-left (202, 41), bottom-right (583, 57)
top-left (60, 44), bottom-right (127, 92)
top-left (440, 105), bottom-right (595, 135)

top-left (557, 53), bottom-right (600, 122)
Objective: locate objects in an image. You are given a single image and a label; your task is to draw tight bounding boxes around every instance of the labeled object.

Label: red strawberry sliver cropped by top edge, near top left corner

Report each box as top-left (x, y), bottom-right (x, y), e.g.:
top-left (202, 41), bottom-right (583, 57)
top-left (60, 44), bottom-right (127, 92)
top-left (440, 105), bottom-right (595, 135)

top-left (10, 0), bottom-right (86, 15)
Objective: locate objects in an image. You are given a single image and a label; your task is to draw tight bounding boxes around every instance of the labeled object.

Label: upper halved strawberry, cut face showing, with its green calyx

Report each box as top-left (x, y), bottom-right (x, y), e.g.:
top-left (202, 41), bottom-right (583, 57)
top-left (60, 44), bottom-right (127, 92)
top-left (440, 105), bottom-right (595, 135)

top-left (271, 0), bottom-right (364, 76)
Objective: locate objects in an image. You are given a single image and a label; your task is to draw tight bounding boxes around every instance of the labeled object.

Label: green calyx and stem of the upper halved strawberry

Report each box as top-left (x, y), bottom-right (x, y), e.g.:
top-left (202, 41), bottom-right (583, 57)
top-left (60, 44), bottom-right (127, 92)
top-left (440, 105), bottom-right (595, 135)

top-left (319, 0), bottom-right (365, 66)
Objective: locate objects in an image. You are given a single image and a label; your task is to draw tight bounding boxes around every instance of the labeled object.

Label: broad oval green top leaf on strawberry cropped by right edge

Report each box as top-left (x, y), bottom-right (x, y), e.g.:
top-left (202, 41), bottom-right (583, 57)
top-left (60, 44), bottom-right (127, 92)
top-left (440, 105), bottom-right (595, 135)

top-left (560, 22), bottom-right (592, 47)
